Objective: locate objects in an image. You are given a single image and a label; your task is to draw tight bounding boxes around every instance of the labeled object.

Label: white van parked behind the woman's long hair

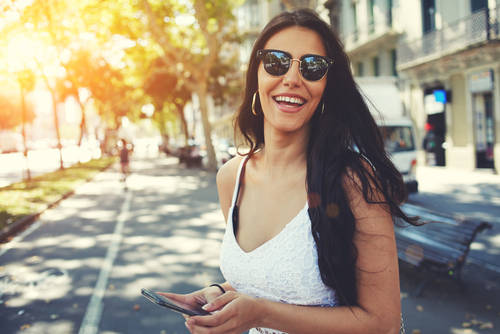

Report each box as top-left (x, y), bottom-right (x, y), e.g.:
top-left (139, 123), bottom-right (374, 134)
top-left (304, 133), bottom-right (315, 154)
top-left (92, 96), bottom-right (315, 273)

top-left (356, 77), bottom-right (418, 192)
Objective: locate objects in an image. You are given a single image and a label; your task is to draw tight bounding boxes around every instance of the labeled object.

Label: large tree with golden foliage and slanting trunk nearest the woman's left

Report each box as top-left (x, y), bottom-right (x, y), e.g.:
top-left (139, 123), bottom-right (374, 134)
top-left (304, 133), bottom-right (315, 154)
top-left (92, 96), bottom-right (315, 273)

top-left (101, 0), bottom-right (243, 170)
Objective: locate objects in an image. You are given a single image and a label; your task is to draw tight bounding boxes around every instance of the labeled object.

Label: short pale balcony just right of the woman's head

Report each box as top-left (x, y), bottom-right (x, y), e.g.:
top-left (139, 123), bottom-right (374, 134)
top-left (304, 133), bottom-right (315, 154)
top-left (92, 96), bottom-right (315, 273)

top-left (342, 11), bottom-right (399, 53)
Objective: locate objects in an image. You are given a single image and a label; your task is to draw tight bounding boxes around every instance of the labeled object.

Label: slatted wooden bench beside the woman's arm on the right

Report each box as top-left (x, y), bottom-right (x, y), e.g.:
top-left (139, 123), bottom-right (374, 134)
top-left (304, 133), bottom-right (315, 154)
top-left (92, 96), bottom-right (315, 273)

top-left (395, 204), bottom-right (492, 296)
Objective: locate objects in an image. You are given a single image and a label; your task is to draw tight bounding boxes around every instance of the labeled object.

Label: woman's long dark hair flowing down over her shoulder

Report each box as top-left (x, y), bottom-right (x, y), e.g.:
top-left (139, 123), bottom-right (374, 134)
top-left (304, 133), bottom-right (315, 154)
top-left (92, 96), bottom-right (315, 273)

top-left (235, 9), bottom-right (417, 306)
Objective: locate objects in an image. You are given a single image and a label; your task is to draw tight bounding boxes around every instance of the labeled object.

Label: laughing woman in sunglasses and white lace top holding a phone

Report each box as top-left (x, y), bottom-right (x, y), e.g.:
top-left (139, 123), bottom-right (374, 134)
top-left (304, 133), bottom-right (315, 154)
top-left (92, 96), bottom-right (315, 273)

top-left (162, 9), bottom-right (414, 334)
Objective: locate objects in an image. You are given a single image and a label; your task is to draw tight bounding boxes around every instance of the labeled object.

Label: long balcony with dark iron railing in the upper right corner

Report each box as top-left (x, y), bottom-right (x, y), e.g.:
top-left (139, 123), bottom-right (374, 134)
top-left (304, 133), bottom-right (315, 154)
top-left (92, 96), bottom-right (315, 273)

top-left (397, 6), bottom-right (500, 71)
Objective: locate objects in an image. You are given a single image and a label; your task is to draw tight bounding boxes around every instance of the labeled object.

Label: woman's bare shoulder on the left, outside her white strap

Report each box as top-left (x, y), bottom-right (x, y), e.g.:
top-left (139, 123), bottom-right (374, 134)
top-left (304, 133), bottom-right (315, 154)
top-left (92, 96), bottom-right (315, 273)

top-left (217, 156), bottom-right (244, 222)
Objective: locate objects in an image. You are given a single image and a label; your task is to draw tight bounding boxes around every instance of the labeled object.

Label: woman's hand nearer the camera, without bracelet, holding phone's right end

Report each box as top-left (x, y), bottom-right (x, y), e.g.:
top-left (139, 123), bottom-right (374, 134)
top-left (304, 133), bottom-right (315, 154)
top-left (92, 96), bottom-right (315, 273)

top-left (186, 291), bottom-right (264, 334)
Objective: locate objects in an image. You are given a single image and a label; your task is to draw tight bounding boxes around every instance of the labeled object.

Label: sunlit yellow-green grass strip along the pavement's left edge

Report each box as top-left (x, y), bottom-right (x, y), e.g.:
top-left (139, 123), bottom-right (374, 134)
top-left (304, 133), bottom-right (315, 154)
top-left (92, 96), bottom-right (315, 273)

top-left (0, 157), bottom-right (117, 230)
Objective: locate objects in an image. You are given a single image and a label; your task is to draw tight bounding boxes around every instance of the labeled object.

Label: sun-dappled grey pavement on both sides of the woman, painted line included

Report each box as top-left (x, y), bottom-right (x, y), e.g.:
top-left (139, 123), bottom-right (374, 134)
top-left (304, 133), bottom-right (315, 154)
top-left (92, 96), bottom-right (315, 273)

top-left (0, 151), bottom-right (500, 334)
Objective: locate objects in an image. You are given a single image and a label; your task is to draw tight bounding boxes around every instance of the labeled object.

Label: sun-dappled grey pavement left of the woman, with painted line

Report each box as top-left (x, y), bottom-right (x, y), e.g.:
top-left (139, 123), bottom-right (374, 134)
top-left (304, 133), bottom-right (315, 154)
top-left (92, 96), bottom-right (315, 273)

top-left (0, 158), bottom-right (225, 334)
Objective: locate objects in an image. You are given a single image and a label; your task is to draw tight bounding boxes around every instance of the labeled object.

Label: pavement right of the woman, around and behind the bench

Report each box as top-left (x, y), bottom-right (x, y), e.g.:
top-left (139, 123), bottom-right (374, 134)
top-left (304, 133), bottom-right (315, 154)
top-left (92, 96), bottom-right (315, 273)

top-left (400, 166), bottom-right (500, 334)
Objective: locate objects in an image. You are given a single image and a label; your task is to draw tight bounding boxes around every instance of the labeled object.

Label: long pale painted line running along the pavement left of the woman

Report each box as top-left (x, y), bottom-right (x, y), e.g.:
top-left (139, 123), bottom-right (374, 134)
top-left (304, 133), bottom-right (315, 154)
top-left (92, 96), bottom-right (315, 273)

top-left (78, 191), bottom-right (132, 334)
